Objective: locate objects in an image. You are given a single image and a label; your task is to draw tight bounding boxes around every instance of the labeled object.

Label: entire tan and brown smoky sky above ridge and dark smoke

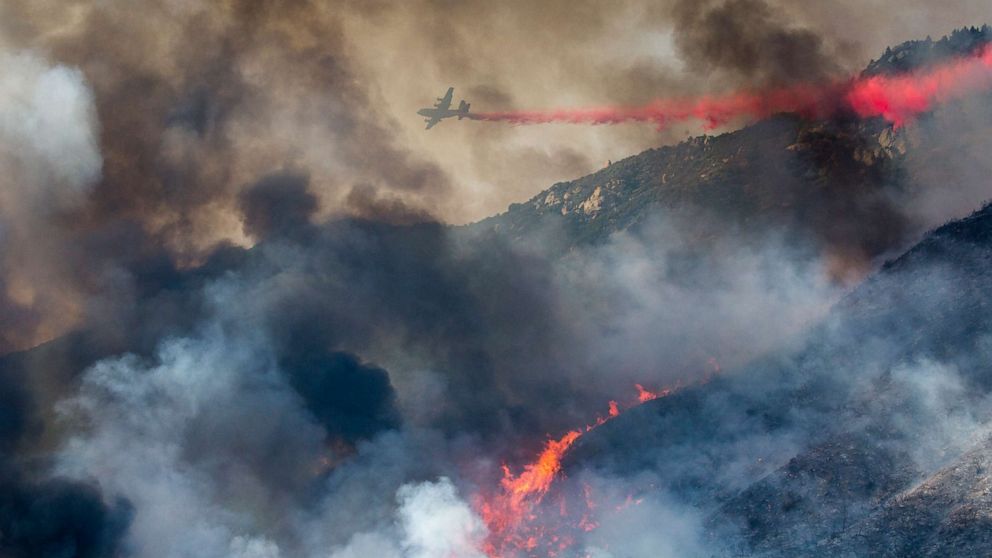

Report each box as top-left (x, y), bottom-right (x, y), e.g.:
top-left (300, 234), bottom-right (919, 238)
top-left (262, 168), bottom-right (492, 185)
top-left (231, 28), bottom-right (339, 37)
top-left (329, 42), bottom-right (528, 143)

top-left (0, 0), bottom-right (988, 346)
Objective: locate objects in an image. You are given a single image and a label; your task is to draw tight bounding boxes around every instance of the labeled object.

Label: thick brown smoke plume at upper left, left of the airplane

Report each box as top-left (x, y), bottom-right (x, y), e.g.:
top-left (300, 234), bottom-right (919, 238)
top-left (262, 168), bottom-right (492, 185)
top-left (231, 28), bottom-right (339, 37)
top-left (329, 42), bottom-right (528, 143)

top-left (0, 1), bottom-right (462, 350)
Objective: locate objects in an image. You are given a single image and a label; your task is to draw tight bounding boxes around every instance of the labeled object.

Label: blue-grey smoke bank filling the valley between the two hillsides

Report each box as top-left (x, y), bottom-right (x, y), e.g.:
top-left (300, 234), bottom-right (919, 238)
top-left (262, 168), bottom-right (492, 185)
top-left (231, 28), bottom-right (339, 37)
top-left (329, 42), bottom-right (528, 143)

top-left (25, 183), bottom-right (835, 556)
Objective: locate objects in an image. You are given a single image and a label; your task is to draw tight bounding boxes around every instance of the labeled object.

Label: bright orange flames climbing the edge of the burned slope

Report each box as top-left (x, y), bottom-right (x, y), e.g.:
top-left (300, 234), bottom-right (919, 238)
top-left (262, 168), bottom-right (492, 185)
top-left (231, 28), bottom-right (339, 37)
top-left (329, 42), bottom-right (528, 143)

top-left (476, 384), bottom-right (672, 558)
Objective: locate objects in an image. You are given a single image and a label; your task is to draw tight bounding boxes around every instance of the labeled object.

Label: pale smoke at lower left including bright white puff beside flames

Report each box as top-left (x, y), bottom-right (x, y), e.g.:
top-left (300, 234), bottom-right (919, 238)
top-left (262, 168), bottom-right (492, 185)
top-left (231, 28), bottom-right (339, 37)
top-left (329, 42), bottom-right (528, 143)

top-left (58, 278), bottom-right (486, 558)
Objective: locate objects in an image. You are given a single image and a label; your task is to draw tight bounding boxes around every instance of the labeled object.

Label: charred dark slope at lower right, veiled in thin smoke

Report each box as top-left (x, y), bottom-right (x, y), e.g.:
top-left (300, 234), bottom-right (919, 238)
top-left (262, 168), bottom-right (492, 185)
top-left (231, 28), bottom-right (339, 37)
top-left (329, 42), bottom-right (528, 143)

top-left (567, 202), bottom-right (992, 556)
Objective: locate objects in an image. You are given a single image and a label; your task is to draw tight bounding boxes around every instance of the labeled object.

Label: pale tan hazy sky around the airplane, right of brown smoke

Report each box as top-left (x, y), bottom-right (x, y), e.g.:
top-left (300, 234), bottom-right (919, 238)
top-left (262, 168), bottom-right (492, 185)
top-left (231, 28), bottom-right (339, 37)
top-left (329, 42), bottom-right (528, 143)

top-left (336, 0), bottom-right (988, 222)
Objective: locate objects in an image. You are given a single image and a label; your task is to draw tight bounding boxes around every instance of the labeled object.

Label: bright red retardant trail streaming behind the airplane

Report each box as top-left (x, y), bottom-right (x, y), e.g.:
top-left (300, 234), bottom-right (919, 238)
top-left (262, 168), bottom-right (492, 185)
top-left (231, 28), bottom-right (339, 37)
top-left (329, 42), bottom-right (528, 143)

top-left (470, 45), bottom-right (992, 129)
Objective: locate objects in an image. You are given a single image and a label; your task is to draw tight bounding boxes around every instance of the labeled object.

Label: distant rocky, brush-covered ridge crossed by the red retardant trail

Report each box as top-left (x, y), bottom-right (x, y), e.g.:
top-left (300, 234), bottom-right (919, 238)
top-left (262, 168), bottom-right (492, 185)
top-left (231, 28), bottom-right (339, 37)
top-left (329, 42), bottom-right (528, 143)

top-left (473, 26), bottom-right (992, 274)
